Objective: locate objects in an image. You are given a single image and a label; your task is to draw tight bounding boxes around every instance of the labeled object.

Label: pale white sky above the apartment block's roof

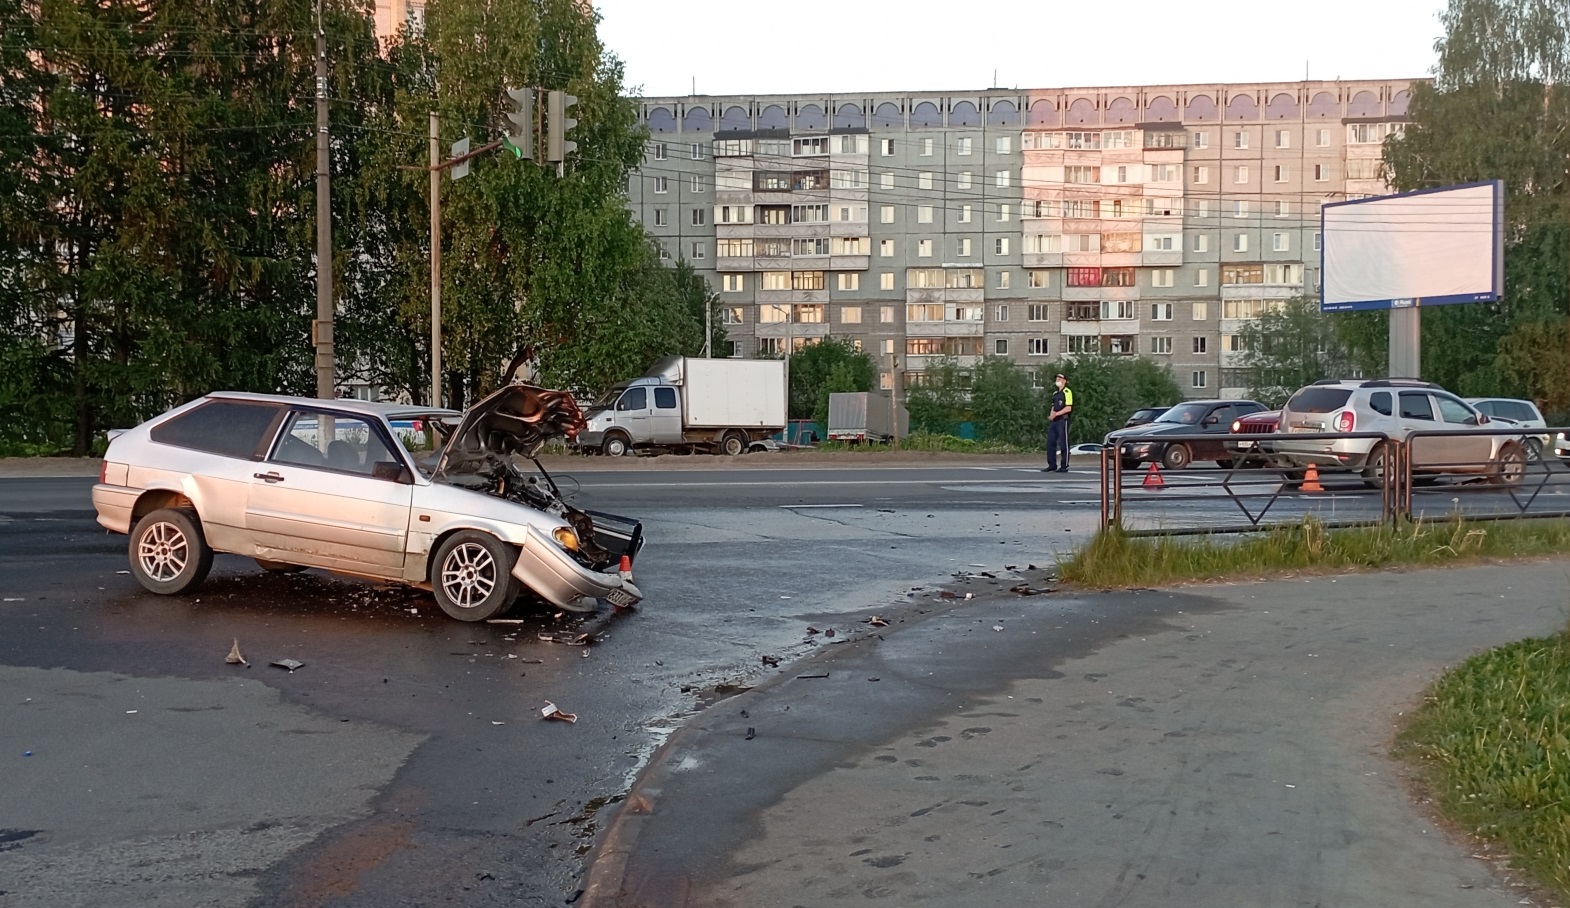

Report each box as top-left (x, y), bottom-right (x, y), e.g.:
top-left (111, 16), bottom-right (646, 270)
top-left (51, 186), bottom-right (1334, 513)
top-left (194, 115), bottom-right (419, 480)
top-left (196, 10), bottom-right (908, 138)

top-left (593, 0), bottom-right (1448, 97)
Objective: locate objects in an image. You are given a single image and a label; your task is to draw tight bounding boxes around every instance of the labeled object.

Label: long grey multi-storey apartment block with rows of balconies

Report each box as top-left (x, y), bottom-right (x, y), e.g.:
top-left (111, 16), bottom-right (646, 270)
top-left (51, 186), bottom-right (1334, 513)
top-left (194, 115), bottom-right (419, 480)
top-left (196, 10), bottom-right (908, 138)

top-left (628, 80), bottom-right (1411, 397)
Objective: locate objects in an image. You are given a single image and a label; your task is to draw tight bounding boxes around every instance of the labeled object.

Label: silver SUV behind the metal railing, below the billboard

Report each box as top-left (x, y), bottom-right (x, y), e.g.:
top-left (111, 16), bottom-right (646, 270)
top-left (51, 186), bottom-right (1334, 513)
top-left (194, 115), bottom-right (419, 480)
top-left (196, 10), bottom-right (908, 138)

top-left (1275, 379), bottom-right (1526, 489)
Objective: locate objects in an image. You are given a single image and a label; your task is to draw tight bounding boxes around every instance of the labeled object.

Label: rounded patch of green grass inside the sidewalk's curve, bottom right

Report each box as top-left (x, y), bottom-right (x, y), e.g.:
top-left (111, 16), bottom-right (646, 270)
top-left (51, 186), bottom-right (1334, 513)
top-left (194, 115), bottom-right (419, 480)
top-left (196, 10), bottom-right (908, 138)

top-left (1396, 633), bottom-right (1570, 897)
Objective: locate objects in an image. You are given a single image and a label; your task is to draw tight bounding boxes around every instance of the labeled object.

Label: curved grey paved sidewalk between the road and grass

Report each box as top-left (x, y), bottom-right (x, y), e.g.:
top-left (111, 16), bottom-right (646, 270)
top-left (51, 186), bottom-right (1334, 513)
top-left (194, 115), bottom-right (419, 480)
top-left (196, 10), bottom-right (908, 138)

top-left (584, 561), bottom-right (1570, 908)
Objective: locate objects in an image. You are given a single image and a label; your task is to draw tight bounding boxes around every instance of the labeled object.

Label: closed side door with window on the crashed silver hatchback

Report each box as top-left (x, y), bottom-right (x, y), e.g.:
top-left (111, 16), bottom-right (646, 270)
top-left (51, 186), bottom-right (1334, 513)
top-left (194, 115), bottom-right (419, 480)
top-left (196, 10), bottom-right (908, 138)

top-left (245, 410), bottom-right (413, 577)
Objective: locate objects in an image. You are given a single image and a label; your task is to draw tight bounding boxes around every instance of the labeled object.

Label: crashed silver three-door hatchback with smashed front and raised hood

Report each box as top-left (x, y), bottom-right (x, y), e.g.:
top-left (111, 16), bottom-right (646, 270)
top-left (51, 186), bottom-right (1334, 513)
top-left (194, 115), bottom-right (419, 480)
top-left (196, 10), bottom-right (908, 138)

top-left (93, 378), bottom-right (644, 621)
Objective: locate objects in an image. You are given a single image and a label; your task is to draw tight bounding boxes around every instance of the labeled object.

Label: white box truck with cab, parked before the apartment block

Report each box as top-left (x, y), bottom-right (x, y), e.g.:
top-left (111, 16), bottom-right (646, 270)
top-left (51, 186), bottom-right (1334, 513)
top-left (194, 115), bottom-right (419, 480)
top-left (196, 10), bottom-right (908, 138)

top-left (578, 357), bottom-right (785, 456)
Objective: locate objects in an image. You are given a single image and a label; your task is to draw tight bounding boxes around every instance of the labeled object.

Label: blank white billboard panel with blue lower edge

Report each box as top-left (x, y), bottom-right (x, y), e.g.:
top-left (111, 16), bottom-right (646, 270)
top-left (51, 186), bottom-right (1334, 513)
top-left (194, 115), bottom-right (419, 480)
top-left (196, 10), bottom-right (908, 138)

top-left (1320, 181), bottom-right (1504, 313)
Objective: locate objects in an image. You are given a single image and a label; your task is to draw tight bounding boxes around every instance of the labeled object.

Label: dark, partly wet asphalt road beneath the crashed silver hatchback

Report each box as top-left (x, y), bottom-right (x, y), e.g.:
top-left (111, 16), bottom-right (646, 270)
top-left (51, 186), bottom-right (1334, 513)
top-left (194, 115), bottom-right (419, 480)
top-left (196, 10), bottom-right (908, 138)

top-left (0, 462), bottom-right (1563, 908)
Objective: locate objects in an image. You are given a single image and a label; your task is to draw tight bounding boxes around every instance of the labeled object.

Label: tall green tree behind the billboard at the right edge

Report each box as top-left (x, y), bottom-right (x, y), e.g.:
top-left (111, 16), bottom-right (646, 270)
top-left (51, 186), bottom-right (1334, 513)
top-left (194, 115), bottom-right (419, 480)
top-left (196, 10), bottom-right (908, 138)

top-left (1385, 0), bottom-right (1570, 394)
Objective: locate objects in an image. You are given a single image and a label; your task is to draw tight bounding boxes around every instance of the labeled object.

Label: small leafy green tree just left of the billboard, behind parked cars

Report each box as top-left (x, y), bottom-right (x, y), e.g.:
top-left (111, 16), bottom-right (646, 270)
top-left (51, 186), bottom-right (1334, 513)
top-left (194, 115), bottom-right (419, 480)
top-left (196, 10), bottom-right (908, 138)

top-left (1223, 297), bottom-right (1355, 407)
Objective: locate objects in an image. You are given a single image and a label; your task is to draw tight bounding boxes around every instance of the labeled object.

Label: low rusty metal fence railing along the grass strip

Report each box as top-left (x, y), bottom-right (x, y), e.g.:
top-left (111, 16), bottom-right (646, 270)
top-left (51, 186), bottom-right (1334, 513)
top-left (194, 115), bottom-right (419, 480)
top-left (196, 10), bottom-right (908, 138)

top-left (1101, 426), bottom-right (1570, 536)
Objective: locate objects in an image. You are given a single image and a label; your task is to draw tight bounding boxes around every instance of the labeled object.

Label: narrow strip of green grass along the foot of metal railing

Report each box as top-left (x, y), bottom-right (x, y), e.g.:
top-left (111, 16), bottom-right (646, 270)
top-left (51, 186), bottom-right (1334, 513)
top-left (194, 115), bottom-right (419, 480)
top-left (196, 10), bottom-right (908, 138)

top-left (1058, 518), bottom-right (1570, 589)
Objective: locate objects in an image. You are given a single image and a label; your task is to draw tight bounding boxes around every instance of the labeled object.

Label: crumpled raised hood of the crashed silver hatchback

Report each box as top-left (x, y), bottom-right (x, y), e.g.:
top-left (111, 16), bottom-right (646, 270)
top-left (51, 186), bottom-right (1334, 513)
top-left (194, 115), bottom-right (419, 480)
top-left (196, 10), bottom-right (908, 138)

top-left (436, 385), bottom-right (589, 476)
